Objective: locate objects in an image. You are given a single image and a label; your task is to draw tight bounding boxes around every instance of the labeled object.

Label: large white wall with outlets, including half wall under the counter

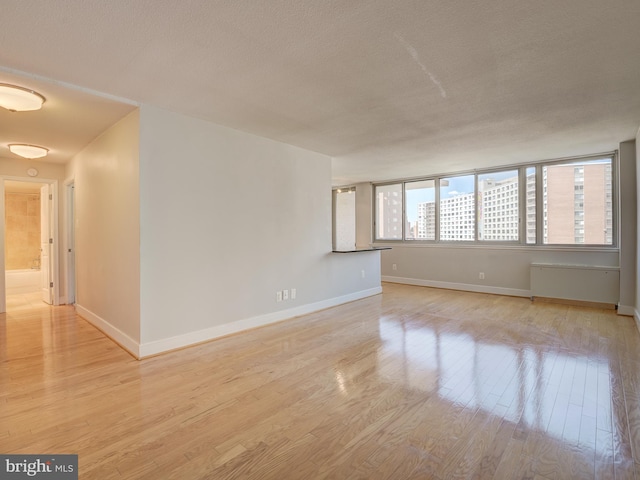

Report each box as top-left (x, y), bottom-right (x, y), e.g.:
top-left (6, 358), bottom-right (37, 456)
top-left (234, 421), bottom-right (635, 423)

top-left (140, 105), bottom-right (380, 356)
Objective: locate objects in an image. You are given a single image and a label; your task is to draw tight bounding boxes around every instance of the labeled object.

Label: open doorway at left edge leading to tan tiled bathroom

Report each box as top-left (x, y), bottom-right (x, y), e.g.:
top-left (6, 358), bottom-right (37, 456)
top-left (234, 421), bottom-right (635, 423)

top-left (0, 177), bottom-right (58, 312)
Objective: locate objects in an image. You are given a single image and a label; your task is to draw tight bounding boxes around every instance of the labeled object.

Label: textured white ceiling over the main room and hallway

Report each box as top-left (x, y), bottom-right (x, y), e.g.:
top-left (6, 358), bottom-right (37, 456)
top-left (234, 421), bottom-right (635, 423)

top-left (0, 0), bottom-right (640, 184)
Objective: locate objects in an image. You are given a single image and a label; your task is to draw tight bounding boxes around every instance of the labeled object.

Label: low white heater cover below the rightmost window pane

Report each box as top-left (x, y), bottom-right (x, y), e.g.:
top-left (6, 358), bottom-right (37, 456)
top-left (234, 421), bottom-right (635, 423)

top-left (531, 263), bottom-right (620, 305)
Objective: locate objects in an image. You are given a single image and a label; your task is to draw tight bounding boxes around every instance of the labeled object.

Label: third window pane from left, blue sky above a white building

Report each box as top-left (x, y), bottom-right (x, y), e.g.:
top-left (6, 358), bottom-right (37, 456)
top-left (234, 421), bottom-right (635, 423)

top-left (439, 175), bottom-right (476, 241)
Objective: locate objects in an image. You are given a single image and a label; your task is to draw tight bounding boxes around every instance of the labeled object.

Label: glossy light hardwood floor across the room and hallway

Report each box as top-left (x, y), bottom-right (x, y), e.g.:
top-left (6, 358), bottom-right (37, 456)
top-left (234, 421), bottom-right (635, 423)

top-left (0, 284), bottom-right (640, 480)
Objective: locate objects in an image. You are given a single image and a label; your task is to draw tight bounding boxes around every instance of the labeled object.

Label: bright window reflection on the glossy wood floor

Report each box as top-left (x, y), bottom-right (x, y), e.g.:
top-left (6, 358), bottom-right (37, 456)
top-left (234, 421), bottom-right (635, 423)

top-left (378, 319), bottom-right (612, 449)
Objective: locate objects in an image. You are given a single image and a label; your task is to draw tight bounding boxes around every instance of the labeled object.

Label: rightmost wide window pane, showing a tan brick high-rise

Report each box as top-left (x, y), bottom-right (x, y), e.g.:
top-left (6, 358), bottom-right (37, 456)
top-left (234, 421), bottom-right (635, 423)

top-left (542, 158), bottom-right (613, 245)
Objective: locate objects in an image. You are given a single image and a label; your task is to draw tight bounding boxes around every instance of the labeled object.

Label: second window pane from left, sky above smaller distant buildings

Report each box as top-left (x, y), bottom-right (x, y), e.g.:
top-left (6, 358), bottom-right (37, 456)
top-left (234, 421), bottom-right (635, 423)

top-left (404, 180), bottom-right (436, 240)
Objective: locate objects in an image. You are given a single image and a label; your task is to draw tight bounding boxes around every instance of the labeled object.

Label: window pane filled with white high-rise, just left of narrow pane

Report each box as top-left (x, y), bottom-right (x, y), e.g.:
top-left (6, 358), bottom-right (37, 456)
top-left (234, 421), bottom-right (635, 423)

top-left (478, 170), bottom-right (519, 242)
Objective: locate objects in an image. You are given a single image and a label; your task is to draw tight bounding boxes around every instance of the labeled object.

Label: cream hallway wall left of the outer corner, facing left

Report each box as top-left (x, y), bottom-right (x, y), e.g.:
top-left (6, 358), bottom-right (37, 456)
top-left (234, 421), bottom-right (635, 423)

top-left (66, 111), bottom-right (140, 348)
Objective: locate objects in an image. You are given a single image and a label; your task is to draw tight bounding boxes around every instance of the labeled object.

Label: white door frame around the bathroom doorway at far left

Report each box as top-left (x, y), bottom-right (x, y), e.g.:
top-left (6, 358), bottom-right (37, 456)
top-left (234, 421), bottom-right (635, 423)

top-left (0, 175), bottom-right (60, 313)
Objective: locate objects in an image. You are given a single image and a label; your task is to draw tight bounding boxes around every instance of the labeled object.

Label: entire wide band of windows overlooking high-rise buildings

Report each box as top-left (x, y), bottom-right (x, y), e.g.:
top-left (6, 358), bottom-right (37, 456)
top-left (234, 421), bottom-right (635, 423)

top-left (374, 155), bottom-right (616, 246)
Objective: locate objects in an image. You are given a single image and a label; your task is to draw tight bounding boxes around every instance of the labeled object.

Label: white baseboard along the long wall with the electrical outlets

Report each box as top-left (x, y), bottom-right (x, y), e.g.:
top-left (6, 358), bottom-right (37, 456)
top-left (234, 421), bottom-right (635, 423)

top-left (139, 287), bottom-right (382, 358)
